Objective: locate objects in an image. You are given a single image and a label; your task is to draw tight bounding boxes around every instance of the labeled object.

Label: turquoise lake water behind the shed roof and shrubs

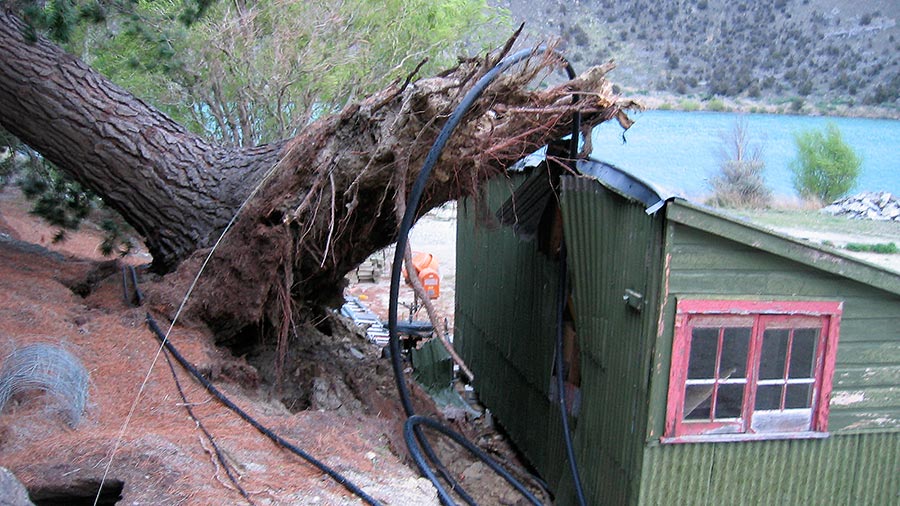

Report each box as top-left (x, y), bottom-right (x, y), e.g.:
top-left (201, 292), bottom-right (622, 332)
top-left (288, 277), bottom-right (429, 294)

top-left (593, 111), bottom-right (900, 198)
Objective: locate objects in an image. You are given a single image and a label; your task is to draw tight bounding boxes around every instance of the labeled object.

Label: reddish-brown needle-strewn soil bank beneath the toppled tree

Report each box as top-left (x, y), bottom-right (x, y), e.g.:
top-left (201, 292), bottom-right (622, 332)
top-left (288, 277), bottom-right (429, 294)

top-left (0, 188), bottom-right (540, 505)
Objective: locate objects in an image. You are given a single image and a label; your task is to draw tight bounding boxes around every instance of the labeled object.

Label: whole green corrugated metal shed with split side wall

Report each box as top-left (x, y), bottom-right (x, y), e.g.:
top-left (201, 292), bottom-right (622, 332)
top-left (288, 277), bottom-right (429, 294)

top-left (456, 156), bottom-right (900, 504)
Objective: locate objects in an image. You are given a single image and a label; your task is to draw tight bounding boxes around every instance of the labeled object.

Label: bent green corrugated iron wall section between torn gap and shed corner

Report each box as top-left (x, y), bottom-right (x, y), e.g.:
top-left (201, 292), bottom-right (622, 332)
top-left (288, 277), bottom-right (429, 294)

top-left (562, 177), bottom-right (662, 504)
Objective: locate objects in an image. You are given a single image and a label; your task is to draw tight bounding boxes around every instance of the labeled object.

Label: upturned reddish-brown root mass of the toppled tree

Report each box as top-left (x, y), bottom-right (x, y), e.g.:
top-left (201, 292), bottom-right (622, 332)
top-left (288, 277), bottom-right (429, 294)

top-left (176, 44), bottom-right (635, 348)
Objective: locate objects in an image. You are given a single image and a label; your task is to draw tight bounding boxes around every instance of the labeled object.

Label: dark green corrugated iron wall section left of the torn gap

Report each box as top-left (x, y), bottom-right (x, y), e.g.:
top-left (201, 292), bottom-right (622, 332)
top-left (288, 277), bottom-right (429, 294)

top-left (454, 174), bottom-right (565, 484)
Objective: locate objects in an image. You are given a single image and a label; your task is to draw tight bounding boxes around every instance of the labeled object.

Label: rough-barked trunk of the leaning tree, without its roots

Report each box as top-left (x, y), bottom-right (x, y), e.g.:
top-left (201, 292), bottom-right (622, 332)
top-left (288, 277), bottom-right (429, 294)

top-left (0, 9), bottom-right (283, 272)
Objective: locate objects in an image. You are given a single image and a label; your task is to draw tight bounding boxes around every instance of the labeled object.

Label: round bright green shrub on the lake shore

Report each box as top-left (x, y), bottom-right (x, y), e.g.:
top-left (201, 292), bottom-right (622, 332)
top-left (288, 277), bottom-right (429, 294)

top-left (790, 123), bottom-right (862, 202)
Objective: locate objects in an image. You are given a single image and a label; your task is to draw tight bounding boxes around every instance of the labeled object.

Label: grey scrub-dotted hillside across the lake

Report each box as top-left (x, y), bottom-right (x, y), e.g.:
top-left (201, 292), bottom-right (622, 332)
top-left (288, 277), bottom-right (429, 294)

top-left (490, 0), bottom-right (900, 111)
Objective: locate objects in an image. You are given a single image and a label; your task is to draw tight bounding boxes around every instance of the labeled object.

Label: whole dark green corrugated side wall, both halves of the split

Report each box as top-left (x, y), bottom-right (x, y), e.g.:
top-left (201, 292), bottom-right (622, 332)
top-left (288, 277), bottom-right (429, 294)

top-left (456, 172), bottom-right (662, 505)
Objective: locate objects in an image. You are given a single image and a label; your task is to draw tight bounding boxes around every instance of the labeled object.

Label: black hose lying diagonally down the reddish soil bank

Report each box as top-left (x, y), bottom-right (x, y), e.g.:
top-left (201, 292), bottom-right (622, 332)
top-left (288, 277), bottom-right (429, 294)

top-left (147, 313), bottom-right (380, 505)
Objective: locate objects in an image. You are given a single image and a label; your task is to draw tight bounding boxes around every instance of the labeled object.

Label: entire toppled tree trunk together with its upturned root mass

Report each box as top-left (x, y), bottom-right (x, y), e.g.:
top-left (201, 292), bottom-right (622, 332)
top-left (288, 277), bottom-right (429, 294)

top-left (0, 7), bottom-right (633, 337)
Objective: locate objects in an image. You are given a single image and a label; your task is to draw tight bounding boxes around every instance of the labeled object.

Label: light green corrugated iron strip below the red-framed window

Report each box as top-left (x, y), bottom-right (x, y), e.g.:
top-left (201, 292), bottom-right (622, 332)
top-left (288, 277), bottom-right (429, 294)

top-left (640, 433), bottom-right (900, 506)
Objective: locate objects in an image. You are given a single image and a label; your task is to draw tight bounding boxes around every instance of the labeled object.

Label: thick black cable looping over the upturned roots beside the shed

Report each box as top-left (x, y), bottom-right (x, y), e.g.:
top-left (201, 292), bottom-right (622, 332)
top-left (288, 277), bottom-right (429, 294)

top-left (388, 47), bottom-right (585, 505)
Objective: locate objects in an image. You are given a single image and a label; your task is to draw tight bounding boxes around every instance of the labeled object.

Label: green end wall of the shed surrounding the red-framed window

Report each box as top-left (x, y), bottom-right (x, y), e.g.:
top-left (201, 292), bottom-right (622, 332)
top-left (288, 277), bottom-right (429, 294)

top-left (640, 201), bottom-right (900, 505)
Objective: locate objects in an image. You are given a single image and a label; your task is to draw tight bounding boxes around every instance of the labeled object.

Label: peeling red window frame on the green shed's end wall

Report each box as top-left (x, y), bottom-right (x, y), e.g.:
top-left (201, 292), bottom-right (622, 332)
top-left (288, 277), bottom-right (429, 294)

top-left (661, 299), bottom-right (843, 443)
